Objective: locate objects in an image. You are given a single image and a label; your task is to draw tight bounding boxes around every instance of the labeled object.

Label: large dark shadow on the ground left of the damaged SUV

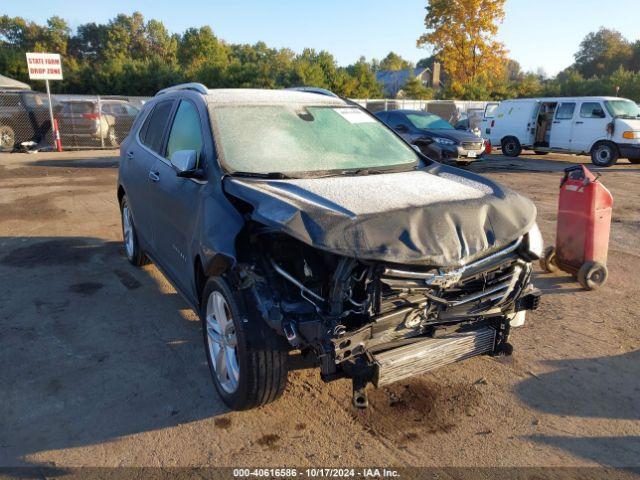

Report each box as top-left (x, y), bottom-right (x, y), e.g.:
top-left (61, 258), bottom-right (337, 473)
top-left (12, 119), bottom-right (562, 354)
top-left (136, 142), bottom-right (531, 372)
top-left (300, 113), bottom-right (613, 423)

top-left (0, 237), bottom-right (226, 466)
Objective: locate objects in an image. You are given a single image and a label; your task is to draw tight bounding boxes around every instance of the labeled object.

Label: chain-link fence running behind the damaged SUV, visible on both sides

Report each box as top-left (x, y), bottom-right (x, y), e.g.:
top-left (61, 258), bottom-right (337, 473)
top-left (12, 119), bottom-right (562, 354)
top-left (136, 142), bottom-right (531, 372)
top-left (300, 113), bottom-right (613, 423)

top-left (0, 90), bottom-right (487, 152)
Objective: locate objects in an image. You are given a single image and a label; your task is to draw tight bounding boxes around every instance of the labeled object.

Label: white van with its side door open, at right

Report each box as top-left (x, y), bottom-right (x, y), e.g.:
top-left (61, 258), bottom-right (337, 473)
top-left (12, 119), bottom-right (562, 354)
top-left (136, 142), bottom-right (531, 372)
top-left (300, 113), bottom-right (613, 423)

top-left (482, 97), bottom-right (640, 167)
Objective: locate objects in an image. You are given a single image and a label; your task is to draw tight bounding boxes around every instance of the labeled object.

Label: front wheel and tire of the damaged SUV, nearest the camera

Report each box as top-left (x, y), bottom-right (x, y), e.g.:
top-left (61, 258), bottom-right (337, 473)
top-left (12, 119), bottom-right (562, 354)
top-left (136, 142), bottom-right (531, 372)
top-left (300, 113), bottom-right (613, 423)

top-left (200, 277), bottom-right (288, 410)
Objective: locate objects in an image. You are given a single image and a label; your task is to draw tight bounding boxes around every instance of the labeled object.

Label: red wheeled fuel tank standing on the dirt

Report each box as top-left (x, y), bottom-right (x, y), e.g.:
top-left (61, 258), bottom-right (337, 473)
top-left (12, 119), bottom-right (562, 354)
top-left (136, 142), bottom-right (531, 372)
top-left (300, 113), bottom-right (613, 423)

top-left (542, 165), bottom-right (613, 290)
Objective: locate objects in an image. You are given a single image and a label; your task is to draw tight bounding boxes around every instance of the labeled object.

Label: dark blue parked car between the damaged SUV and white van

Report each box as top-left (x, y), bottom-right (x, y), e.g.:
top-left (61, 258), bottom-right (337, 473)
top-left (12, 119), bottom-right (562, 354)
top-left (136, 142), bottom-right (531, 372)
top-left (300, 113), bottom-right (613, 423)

top-left (375, 110), bottom-right (484, 165)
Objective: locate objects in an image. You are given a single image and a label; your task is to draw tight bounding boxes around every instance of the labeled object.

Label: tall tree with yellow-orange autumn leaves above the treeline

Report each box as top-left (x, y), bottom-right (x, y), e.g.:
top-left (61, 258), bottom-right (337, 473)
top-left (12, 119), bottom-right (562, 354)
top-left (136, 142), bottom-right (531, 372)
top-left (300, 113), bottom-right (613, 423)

top-left (417, 0), bottom-right (507, 86)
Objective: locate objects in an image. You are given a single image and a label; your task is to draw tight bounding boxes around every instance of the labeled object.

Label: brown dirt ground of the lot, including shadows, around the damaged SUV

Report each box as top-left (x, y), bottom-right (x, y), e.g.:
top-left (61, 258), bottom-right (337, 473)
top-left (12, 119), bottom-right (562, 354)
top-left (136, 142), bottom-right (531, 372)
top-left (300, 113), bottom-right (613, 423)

top-left (0, 152), bottom-right (640, 467)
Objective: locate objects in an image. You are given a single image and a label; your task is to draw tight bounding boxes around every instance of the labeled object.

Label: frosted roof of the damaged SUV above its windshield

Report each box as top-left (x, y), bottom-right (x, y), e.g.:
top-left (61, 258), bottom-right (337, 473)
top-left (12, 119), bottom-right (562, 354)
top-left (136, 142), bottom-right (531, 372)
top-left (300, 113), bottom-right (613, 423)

top-left (204, 88), bottom-right (349, 107)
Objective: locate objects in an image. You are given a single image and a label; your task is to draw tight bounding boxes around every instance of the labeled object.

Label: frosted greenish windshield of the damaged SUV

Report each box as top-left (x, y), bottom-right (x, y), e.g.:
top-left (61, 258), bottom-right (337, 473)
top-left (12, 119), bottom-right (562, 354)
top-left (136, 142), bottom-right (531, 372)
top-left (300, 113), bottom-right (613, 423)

top-left (211, 103), bottom-right (418, 174)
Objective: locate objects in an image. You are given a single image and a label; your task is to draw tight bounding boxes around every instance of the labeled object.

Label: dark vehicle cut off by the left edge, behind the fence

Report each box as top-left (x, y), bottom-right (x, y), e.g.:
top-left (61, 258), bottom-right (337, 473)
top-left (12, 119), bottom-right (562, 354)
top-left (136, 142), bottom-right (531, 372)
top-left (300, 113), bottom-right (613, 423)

top-left (0, 89), bottom-right (60, 151)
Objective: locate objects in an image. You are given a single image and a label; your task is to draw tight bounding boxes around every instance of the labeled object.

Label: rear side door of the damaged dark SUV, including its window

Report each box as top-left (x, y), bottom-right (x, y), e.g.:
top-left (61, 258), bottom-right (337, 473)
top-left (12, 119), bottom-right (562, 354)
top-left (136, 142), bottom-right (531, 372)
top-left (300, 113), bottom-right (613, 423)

top-left (120, 100), bottom-right (174, 254)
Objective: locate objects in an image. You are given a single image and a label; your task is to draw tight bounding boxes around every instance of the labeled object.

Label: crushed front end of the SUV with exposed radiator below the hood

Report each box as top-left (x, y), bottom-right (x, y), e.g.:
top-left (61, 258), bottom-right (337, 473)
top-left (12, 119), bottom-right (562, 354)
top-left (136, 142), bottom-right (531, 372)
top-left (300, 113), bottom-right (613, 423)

top-left (238, 227), bottom-right (540, 407)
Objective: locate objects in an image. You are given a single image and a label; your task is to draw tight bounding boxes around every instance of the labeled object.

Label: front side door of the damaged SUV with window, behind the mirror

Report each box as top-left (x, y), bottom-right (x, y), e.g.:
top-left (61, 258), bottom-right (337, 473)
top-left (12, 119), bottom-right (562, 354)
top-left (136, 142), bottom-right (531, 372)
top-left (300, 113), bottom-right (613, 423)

top-left (150, 99), bottom-right (205, 292)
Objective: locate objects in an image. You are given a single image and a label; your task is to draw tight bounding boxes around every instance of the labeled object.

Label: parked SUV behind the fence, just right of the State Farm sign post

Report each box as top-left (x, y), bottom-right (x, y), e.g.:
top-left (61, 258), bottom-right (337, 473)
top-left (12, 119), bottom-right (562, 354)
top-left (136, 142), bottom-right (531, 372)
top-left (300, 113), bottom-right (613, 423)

top-left (57, 99), bottom-right (139, 147)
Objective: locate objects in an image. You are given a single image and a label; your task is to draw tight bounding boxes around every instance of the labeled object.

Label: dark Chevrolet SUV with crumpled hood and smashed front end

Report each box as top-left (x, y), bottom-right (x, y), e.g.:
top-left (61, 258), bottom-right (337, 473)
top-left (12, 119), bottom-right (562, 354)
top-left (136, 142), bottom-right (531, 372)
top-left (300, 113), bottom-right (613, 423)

top-left (118, 84), bottom-right (542, 409)
